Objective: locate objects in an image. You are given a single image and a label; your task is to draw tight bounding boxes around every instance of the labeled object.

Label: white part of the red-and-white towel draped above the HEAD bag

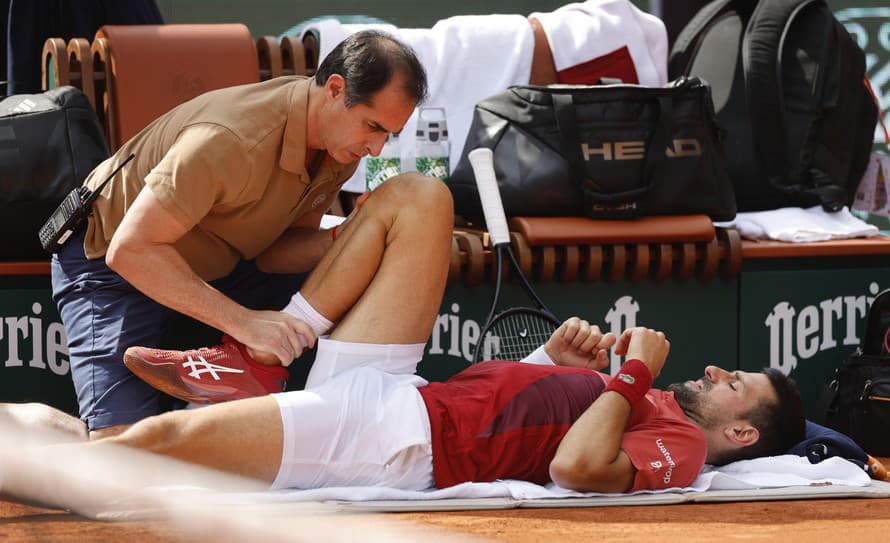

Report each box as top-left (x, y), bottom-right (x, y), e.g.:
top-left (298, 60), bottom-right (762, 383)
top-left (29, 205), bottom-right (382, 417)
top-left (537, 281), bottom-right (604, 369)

top-left (530, 0), bottom-right (668, 87)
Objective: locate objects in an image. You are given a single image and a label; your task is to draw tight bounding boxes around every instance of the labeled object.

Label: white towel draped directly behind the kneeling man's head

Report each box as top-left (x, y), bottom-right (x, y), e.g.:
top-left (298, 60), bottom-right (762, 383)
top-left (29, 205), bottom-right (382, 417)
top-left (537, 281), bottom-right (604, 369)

top-left (303, 15), bottom-right (534, 192)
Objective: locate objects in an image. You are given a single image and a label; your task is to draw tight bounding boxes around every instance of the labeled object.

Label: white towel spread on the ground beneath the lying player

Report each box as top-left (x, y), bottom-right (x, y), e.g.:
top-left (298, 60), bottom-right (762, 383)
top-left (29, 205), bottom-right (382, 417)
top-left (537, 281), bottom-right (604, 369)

top-left (262, 455), bottom-right (871, 501)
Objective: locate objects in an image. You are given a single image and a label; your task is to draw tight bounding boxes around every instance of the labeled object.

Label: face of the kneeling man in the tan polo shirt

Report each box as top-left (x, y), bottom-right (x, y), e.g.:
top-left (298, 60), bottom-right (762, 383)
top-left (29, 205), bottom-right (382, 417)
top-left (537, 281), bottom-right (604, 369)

top-left (321, 75), bottom-right (415, 164)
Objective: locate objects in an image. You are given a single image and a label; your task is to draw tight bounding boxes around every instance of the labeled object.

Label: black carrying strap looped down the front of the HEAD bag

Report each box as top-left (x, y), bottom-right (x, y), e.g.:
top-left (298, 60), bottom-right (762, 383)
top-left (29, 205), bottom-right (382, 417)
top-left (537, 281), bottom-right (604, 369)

top-left (550, 89), bottom-right (668, 204)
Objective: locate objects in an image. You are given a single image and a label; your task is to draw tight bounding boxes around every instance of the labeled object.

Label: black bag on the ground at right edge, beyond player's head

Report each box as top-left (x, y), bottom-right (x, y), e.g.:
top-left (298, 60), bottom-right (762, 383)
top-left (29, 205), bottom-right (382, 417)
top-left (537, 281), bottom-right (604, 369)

top-left (826, 289), bottom-right (890, 456)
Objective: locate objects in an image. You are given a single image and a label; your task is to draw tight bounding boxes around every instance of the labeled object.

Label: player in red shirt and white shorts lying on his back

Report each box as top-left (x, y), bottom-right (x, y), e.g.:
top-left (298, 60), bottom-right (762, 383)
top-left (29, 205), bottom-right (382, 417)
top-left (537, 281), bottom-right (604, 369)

top-left (1, 179), bottom-right (804, 500)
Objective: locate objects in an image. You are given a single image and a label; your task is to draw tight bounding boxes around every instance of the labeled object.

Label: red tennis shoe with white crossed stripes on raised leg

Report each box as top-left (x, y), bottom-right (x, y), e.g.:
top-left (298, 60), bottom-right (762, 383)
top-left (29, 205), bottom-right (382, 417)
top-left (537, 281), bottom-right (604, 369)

top-left (124, 336), bottom-right (289, 403)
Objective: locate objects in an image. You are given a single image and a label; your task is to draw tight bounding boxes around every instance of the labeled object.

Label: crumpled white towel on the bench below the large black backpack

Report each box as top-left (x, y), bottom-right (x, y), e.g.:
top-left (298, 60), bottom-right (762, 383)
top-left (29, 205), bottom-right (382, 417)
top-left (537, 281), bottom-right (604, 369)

top-left (714, 206), bottom-right (879, 243)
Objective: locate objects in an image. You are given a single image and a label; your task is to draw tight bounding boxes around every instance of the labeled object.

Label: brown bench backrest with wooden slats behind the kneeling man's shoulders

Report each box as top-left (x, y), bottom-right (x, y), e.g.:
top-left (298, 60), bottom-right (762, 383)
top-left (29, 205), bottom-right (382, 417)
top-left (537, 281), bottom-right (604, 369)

top-left (42, 24), bottom-right (317, 152)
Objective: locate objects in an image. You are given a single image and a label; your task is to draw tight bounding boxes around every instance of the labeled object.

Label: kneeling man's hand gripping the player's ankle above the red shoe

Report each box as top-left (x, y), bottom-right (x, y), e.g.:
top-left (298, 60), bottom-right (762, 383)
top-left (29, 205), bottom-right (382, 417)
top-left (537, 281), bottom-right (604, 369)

top-left (229, 311), bottom-right (316, 366)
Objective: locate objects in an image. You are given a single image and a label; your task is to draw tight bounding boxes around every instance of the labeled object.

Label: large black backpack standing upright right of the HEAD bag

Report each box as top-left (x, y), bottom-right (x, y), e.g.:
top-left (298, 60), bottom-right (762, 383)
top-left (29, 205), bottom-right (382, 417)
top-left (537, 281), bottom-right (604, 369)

top-left (668, 0), bottom-right (878, 211)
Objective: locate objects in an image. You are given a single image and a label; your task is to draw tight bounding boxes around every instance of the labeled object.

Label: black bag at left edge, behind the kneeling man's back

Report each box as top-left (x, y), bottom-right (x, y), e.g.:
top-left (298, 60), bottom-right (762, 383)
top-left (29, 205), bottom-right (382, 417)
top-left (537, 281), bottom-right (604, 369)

top-left (0, 87), bottom-right (108, 261)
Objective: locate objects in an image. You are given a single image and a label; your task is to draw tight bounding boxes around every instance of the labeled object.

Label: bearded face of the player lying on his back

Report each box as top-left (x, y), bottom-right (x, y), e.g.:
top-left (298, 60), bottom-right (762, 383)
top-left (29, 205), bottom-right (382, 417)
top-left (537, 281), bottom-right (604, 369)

top-left (668, 366), bottom-right (776, 429)
